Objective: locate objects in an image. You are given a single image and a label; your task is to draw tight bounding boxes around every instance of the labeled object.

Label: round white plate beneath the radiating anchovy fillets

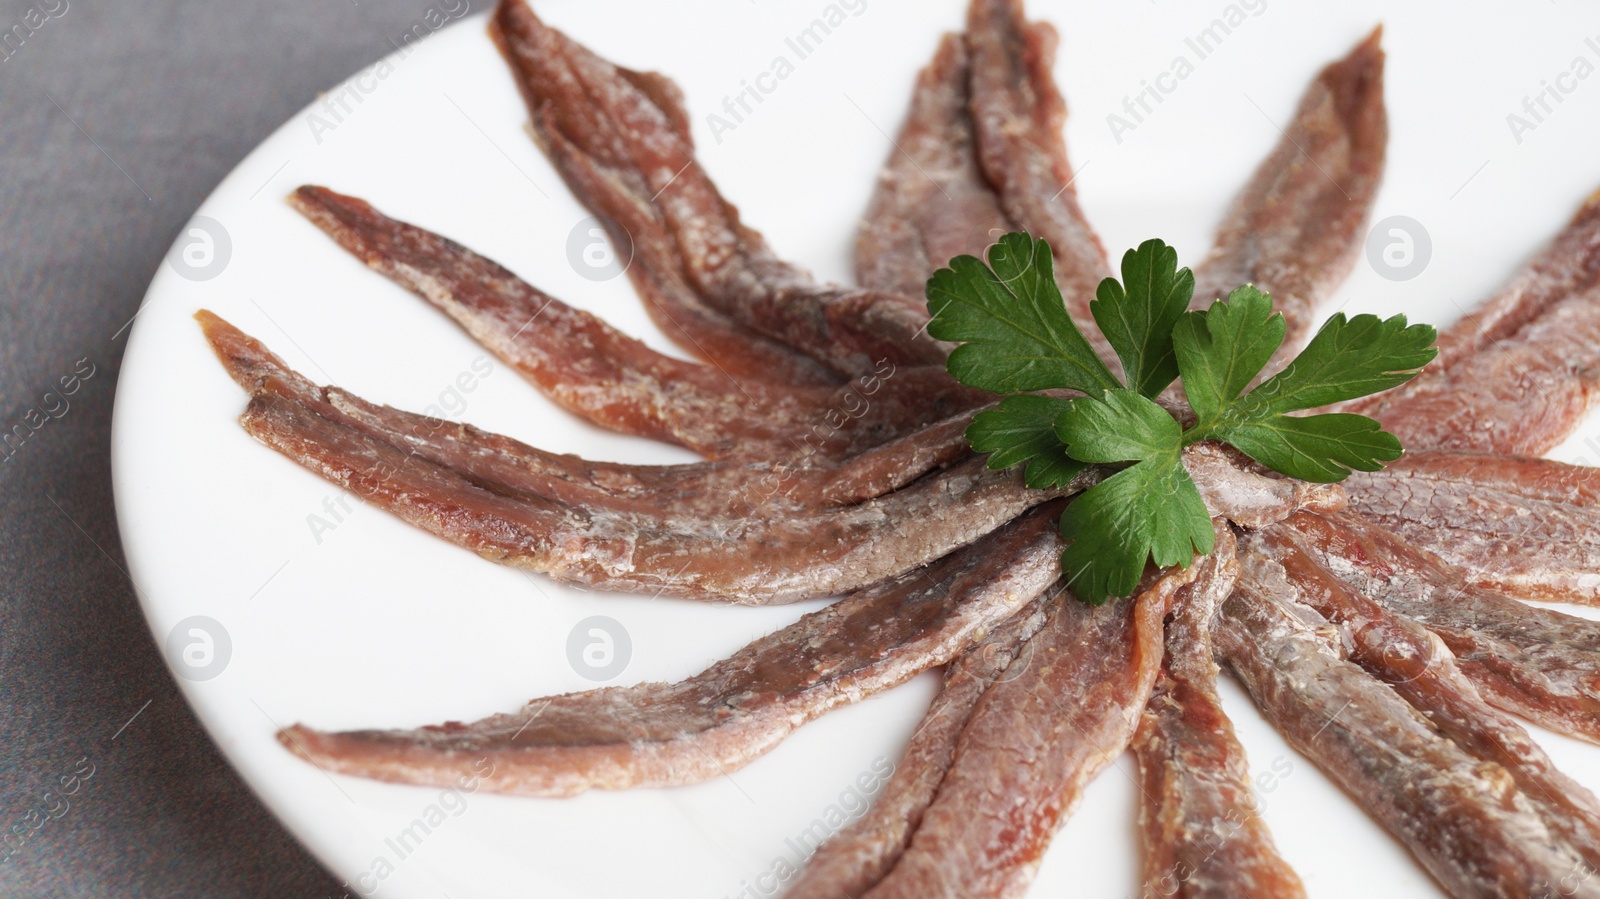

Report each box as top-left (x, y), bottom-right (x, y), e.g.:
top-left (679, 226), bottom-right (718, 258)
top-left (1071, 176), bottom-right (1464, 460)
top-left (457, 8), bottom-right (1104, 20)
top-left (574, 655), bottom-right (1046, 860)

top-left (114, 0), bottom-right (1600, 899)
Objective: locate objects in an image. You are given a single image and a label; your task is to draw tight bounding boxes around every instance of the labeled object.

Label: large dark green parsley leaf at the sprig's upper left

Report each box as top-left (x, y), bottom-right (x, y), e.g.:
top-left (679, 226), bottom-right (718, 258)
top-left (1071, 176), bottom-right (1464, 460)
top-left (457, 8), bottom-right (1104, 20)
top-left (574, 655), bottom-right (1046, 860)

top-left (928, 232), bottom-right (1122, 394)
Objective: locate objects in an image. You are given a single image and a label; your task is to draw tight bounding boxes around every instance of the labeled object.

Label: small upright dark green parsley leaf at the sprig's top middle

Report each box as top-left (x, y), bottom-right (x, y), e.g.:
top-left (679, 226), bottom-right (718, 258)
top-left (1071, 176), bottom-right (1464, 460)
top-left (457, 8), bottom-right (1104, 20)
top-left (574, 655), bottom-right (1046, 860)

top-left (1090, 240), bottom-right (1195, 397)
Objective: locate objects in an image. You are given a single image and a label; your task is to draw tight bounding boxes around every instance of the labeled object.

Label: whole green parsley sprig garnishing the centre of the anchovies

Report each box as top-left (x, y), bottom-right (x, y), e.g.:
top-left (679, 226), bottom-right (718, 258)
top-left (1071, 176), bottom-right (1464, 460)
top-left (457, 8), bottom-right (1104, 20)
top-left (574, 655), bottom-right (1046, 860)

top-left (928, 232), bottom-right (1437, 605)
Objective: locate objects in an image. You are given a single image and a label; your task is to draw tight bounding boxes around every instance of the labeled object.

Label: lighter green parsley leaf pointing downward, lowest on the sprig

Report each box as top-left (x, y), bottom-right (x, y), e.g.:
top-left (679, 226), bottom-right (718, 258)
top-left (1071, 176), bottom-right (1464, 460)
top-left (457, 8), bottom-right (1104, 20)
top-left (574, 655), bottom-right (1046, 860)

top-left (1056, 390), bottom-right (1216, 605)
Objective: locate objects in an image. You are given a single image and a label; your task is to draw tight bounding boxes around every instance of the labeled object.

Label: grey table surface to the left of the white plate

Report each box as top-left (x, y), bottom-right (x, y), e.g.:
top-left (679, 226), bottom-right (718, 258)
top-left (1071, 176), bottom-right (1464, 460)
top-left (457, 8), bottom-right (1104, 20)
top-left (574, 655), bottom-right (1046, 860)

top-left (0, 0), bottom-right (483, 897)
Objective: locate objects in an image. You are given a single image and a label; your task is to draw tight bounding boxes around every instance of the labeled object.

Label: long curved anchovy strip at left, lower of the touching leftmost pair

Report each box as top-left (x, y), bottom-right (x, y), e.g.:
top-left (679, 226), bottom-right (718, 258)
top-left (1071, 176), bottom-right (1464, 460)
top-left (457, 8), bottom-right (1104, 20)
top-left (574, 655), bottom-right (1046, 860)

top-left (202, 307), bottom-right (1062, 605)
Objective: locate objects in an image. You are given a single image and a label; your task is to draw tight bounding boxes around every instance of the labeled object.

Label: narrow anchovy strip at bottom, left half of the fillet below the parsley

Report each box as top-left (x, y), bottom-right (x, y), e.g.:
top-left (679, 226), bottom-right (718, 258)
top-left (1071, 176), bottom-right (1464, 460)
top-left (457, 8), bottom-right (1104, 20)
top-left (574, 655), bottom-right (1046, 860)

top-left (784, 588), bottom-right (1050, 899)
